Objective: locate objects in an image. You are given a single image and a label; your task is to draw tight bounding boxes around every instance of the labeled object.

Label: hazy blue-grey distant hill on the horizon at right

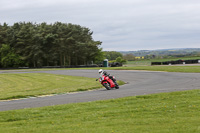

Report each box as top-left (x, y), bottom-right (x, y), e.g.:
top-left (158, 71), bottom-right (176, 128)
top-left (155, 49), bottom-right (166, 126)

top-left (117, 48), bottom-right (200, 56)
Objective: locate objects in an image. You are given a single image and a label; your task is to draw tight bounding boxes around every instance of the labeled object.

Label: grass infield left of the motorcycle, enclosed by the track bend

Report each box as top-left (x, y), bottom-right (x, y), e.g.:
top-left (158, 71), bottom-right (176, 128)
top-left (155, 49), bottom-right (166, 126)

top-left (0, 73), bottom-right (123, 100)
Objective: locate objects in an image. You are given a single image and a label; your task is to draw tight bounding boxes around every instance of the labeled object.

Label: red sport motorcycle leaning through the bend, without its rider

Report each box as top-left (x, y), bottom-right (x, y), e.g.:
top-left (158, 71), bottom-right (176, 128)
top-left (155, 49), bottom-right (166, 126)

top-left (96, 75), bottom-right (119, 90)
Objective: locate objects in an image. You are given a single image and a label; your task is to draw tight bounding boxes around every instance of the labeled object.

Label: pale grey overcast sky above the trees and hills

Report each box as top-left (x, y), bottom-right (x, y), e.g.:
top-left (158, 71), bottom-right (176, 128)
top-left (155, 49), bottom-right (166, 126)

top-left (0, 0), bottom-right (200, 51)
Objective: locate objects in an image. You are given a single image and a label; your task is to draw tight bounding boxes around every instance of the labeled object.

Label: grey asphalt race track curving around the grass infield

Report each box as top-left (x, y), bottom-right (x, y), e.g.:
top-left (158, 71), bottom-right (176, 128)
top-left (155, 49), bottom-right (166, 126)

top-left (0, 70), bottom-right (200, 111)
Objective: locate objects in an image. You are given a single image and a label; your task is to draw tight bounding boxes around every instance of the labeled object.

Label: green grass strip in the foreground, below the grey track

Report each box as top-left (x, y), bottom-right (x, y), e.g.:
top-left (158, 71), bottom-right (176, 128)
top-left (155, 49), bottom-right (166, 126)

top-left (0, 90), bottom-right (200, 133)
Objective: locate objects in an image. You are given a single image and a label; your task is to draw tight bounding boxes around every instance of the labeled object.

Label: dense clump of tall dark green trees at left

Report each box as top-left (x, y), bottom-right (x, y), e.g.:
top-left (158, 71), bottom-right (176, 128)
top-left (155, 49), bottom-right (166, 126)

top-left (0, 22), bottom-right (104, 68)
